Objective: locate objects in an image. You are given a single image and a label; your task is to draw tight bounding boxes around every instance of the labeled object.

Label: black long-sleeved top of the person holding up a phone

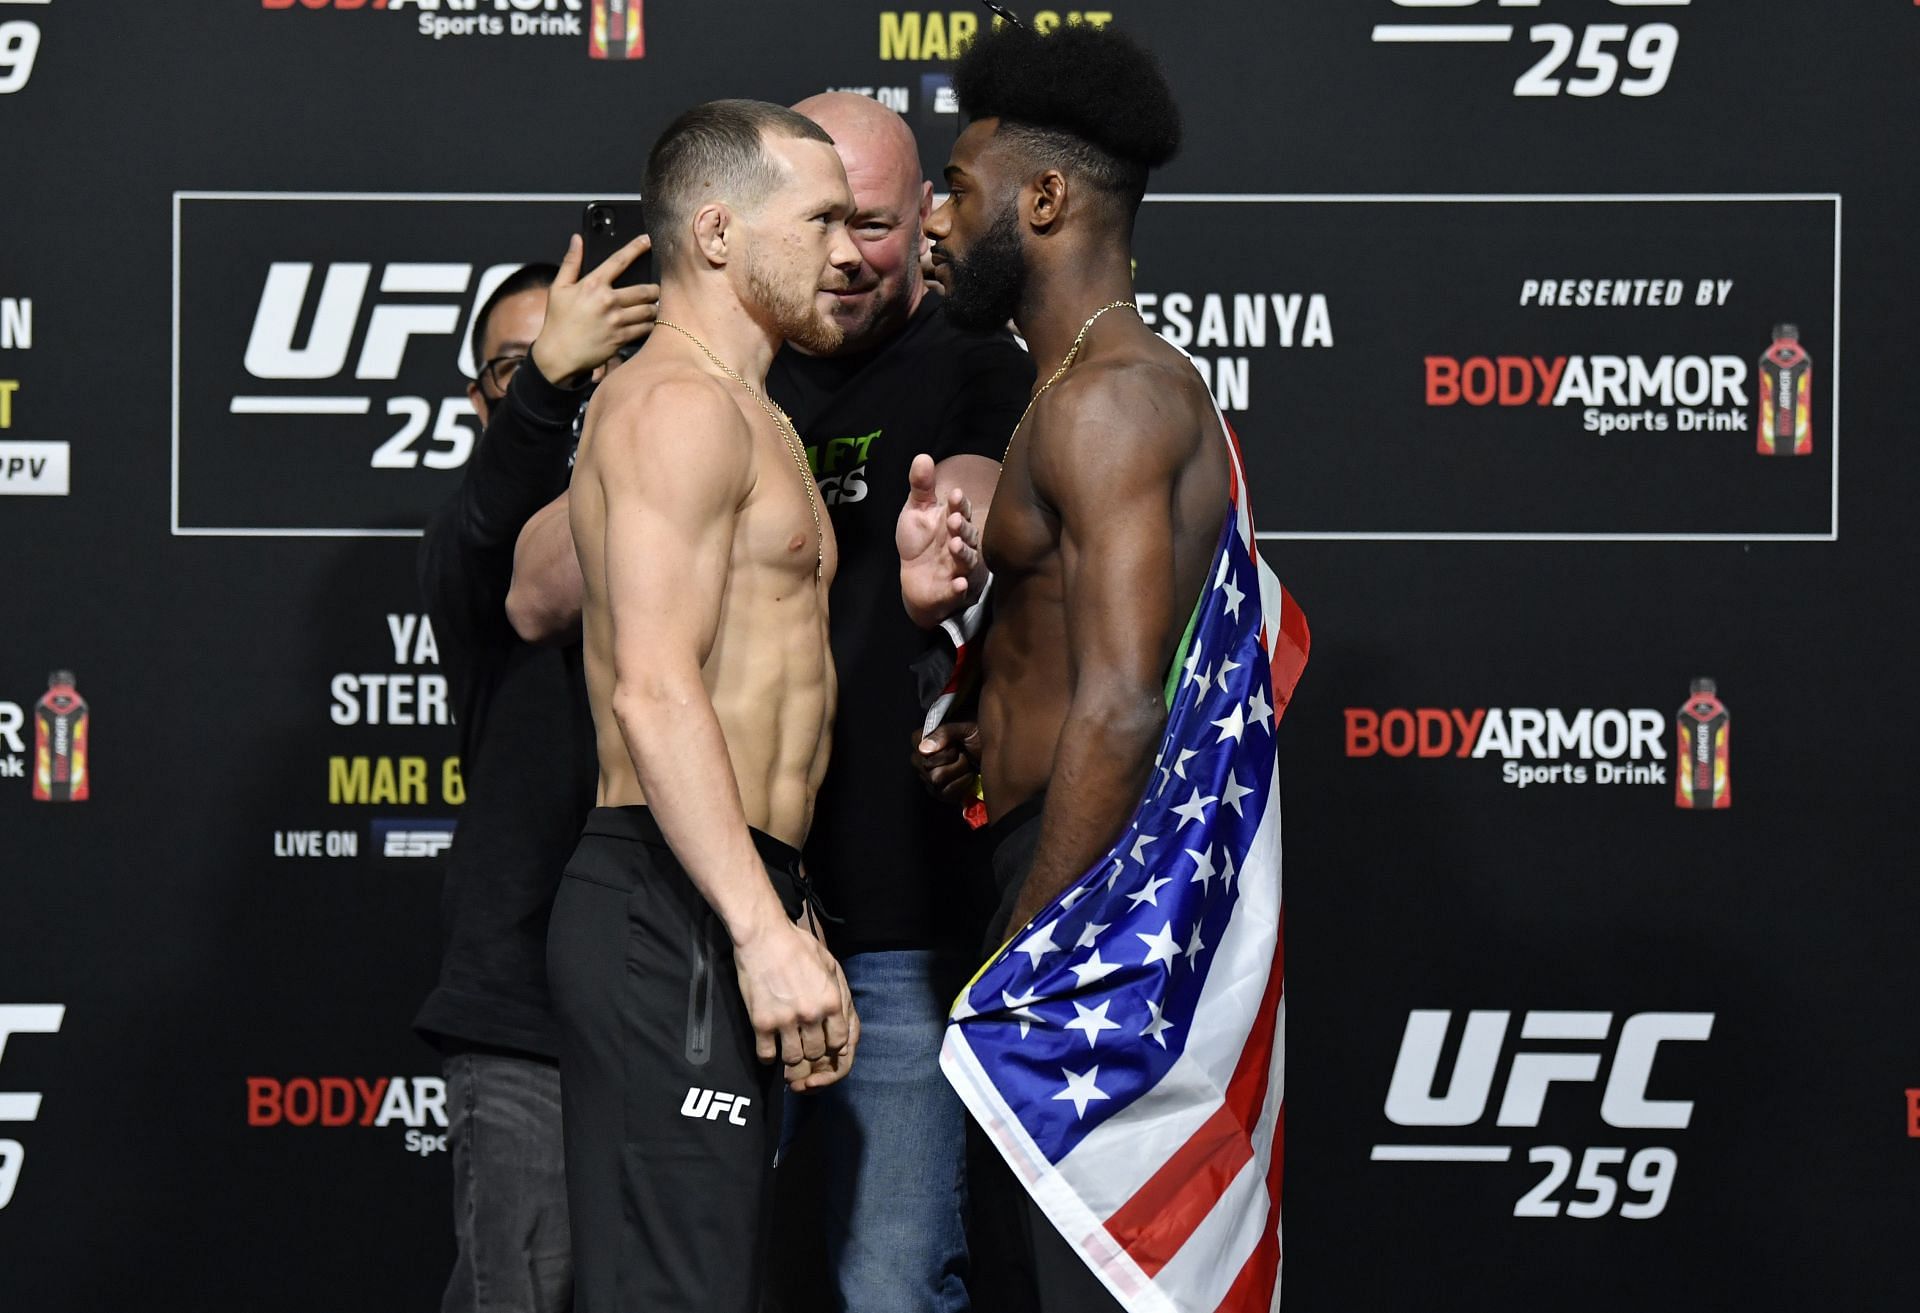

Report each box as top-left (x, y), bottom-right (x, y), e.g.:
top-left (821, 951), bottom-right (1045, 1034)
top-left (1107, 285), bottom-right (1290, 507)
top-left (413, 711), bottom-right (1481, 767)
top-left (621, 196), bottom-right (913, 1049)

top-left (413, 365), bottom-right (599, 1058)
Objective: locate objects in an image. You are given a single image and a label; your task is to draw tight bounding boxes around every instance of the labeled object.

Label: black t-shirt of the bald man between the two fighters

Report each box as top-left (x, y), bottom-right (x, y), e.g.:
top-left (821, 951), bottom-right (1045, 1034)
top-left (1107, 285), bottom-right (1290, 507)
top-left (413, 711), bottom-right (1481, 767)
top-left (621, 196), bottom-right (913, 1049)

top-left (766, 292), bottom-right (1033, 954)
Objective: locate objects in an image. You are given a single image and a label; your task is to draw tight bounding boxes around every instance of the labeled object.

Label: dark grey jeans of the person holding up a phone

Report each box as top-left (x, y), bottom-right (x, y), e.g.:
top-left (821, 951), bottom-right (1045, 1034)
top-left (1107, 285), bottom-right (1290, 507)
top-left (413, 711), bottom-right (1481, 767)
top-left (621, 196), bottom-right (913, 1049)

top-left (440, 1054), bottom-right (574, 1313)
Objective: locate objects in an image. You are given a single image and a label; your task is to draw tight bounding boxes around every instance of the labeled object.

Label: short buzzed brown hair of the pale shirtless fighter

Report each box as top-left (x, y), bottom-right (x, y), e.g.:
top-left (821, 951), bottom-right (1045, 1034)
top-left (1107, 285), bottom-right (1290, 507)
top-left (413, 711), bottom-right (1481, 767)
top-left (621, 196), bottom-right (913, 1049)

top-left (645, 100), bottom-right (833, 267)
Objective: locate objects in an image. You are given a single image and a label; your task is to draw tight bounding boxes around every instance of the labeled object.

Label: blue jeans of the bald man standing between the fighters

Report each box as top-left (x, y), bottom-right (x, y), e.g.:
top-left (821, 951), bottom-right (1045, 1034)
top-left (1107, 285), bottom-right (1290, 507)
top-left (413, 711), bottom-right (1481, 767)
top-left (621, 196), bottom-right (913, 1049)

top-left (785, 952), bottom-right (968, 1313)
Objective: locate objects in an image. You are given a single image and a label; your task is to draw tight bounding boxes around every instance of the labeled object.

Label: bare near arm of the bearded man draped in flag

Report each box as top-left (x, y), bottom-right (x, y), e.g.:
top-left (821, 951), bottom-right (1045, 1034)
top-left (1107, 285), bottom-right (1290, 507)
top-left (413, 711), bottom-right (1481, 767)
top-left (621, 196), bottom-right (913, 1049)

top-left (1008, 367), bottom-right (1187, 931)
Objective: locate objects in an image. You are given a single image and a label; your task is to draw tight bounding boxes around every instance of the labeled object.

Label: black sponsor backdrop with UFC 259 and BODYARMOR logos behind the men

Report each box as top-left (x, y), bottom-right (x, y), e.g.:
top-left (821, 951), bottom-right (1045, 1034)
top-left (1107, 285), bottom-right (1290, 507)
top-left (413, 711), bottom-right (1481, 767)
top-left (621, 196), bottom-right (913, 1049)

top-left (0, 0), bottom-right (1920, 1313)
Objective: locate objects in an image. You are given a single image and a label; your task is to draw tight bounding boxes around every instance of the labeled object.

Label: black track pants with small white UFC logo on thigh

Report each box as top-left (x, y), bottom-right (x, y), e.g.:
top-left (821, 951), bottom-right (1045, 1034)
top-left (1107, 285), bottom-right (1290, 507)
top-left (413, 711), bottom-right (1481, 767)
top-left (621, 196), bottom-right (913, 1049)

top-left (547, 806), bottom-right (803, 1313)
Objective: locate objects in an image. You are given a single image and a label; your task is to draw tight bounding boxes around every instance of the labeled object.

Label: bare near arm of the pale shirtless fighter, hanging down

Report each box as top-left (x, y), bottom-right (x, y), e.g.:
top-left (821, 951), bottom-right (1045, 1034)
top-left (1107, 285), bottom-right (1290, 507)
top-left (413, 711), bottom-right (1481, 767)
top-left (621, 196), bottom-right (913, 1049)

top-left (593, 382), bottom-right (854, 1088)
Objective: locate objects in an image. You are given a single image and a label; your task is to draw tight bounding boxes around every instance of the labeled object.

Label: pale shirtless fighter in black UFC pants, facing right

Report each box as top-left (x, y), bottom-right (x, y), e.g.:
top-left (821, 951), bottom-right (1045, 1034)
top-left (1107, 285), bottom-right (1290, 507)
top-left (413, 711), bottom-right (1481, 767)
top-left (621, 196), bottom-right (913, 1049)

top-left (549, 100), bottom-right (860, 1313)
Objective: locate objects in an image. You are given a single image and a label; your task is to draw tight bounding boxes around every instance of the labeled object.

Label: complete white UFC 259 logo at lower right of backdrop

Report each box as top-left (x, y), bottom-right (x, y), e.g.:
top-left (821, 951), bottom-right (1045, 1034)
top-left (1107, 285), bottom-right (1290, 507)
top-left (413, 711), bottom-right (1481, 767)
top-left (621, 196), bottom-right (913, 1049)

top-left (1373, 1010), bottom-right (1713, 1221)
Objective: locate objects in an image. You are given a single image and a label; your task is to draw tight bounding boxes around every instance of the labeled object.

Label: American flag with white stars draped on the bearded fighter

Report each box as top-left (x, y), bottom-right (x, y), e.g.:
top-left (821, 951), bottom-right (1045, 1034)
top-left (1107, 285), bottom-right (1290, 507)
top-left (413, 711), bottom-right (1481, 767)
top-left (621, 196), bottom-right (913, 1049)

top-left (941, 381), bottom-right (1308, 1313)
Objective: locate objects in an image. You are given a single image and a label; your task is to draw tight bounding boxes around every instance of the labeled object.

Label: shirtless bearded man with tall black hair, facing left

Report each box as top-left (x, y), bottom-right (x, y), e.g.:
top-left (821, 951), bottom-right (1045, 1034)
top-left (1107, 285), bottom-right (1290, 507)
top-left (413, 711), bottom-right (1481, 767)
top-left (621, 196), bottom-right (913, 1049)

top-left (899, 23), bottom-right (1229, 1313)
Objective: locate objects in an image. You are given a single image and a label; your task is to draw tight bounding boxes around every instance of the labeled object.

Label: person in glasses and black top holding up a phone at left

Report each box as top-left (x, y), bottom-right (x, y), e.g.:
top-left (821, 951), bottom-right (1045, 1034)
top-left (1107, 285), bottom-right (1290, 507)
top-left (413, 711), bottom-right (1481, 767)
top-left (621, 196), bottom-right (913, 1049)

top-left (415, 236), bottom-right (659, 1313)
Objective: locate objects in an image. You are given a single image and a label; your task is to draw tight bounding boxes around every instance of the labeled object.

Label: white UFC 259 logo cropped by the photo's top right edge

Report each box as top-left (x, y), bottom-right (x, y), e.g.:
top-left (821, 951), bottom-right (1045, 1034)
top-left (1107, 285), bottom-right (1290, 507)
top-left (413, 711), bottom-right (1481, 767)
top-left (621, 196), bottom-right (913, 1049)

top-left (1373, 0), bottom-right (1692, 96)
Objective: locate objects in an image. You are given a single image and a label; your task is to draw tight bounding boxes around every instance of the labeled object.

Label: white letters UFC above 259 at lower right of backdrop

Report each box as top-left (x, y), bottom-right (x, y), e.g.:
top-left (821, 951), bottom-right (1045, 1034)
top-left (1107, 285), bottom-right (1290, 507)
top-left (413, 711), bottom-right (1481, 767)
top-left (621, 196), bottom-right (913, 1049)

top-left (1386, 1010), bottom-right (1713, 1129)
